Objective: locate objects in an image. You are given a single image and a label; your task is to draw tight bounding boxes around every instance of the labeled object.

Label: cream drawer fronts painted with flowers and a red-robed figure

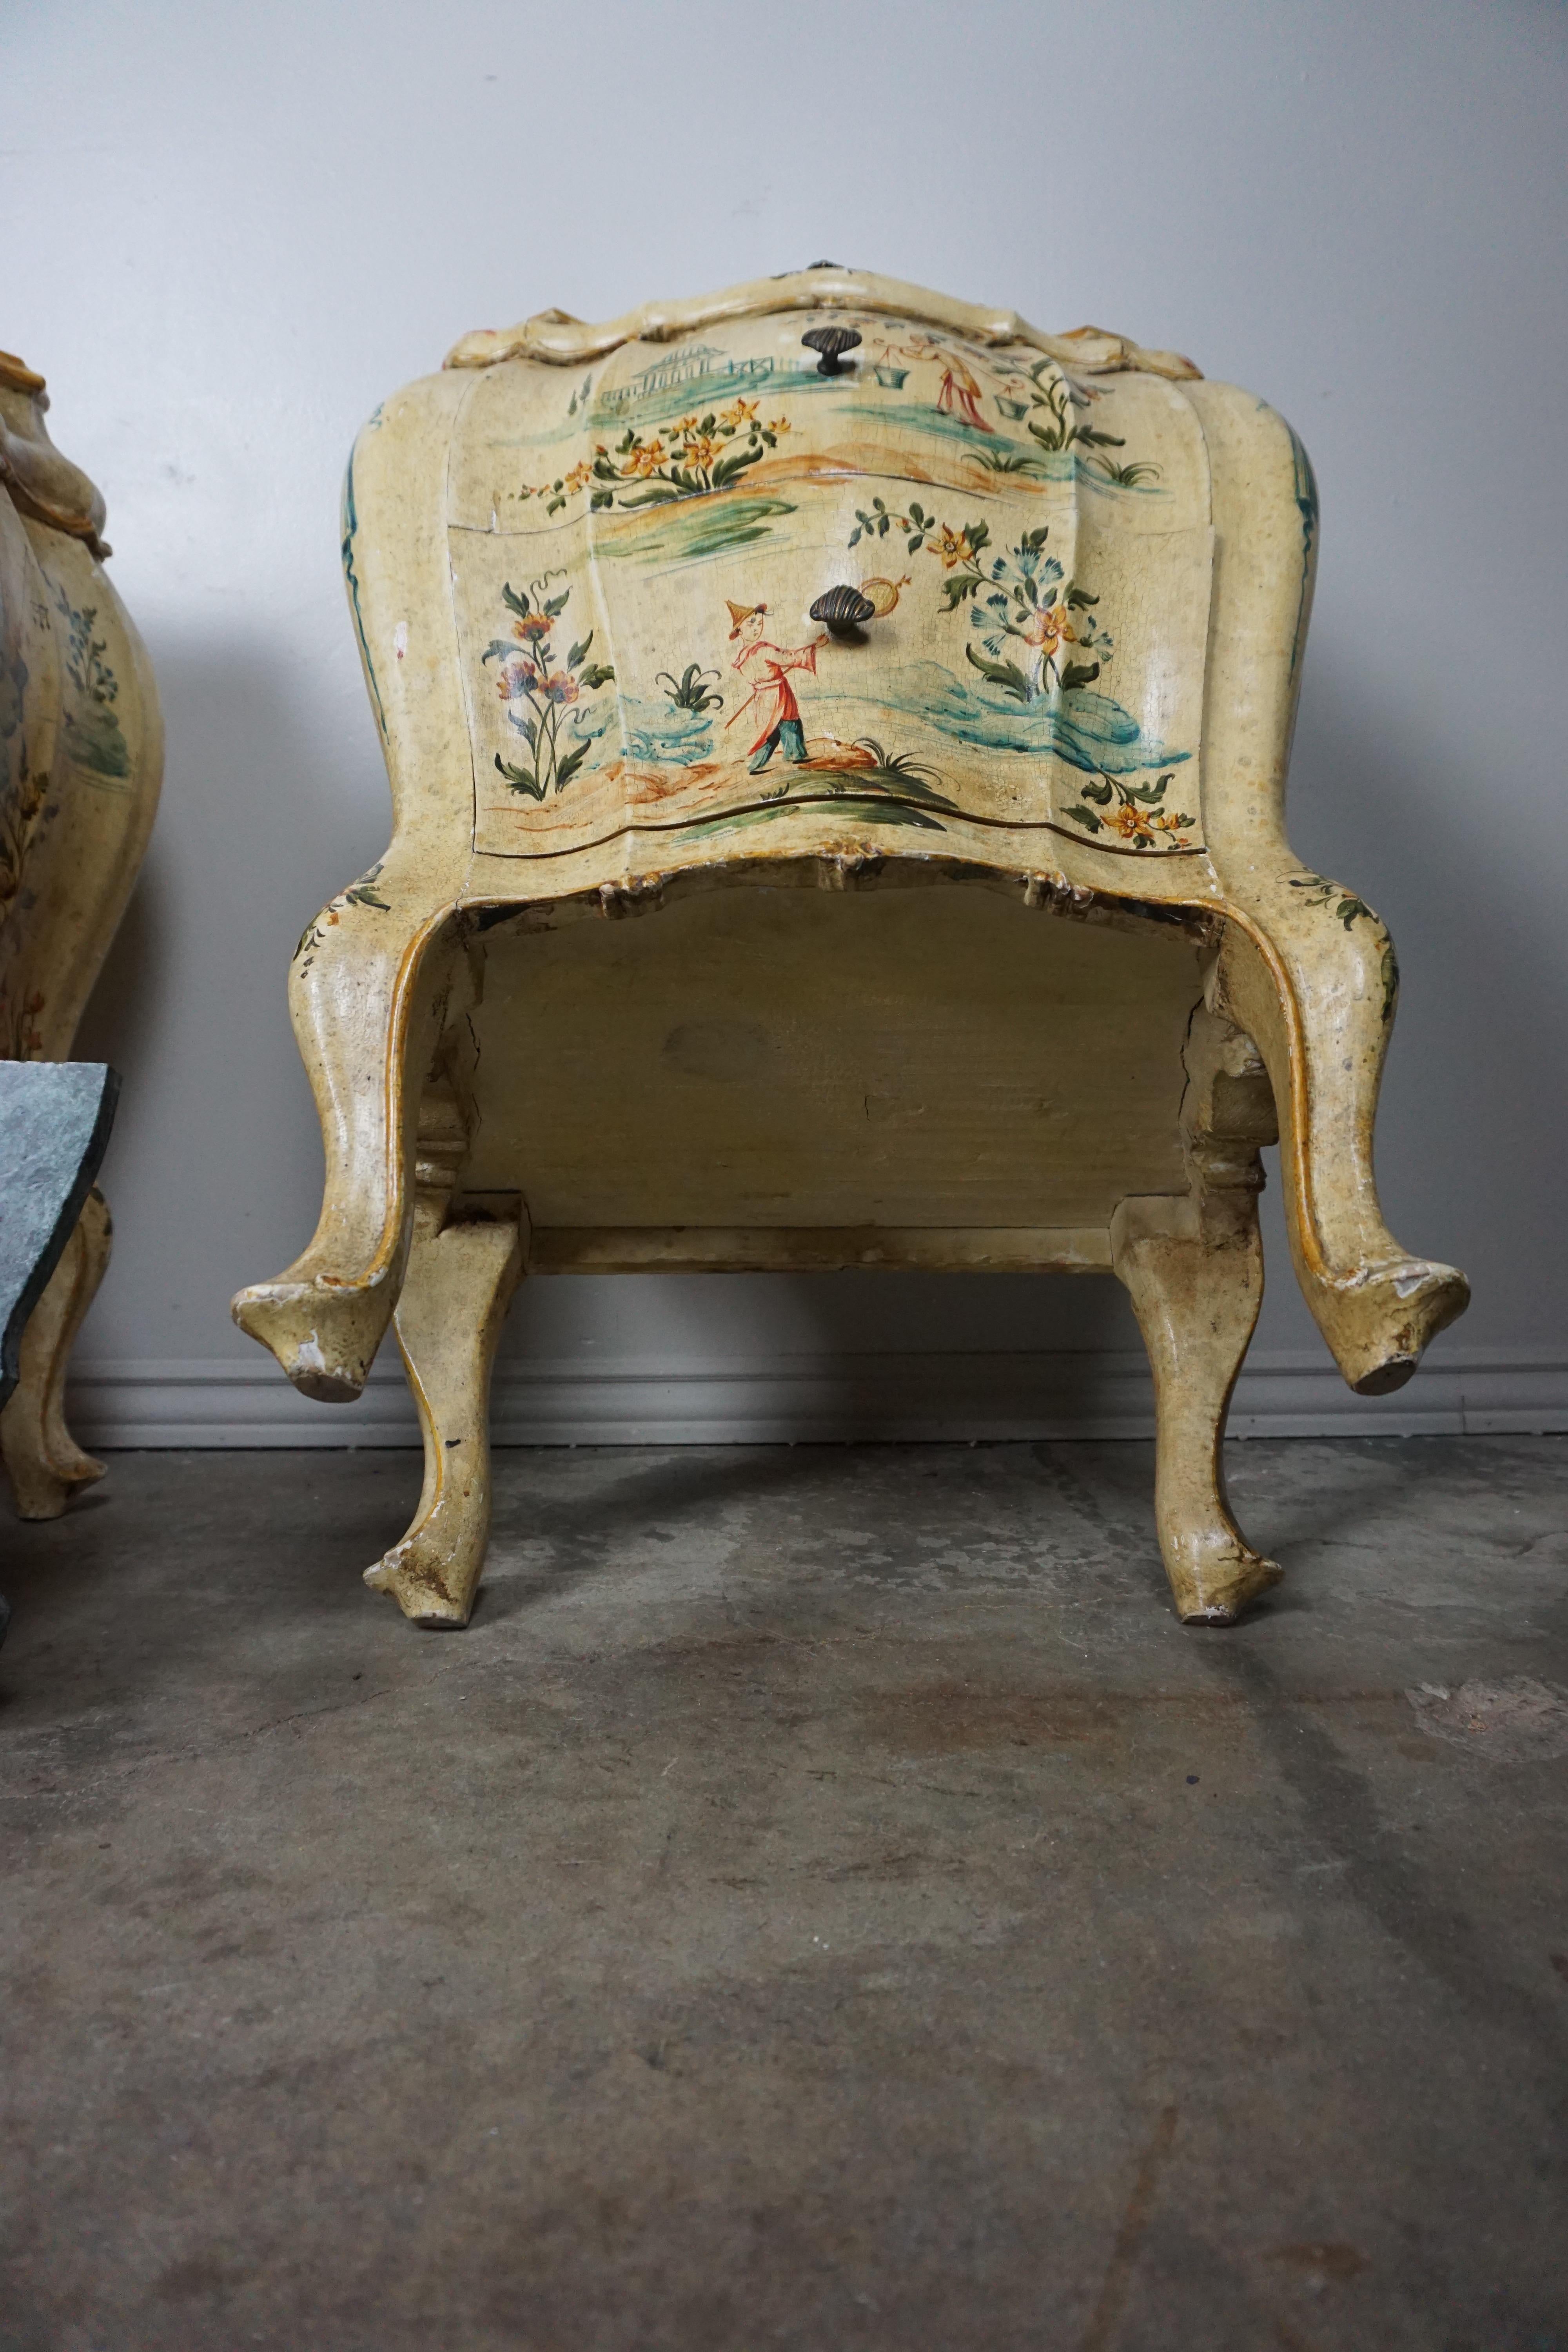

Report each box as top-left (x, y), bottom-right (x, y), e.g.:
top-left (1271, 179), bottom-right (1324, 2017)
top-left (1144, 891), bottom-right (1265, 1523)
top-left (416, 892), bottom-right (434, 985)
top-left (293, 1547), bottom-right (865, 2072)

top-left (442, 308), bottom-right (1210, 891)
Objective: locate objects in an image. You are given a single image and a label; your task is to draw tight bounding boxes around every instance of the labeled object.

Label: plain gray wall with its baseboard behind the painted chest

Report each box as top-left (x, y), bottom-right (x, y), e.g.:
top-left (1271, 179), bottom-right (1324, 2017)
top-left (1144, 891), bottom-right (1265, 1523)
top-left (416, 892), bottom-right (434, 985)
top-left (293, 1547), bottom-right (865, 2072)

top-left (0, 0), bottom-right (1568, 1442)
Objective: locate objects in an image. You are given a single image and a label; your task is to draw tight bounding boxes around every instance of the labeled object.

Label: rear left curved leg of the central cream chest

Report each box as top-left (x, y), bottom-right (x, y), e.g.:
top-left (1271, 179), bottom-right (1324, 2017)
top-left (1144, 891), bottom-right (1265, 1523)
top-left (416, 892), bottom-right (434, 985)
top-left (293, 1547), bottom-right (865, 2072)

top-left (365, 1200), bottom-right (522, 1625)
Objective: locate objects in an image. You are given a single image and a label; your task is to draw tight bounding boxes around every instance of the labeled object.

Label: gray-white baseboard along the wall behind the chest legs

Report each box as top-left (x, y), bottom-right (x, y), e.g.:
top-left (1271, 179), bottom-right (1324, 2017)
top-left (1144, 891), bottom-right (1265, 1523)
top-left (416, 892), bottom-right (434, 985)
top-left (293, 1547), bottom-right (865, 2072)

top-left (58, 1348), bottom-right (1568, 1446)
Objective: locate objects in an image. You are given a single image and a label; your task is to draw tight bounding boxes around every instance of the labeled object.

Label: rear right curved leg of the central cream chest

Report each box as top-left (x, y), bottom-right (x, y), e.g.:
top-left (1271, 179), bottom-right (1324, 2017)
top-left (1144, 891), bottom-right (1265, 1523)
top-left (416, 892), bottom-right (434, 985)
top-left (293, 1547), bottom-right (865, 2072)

top-left (1112, 1192), bottom-right (1283, 1625)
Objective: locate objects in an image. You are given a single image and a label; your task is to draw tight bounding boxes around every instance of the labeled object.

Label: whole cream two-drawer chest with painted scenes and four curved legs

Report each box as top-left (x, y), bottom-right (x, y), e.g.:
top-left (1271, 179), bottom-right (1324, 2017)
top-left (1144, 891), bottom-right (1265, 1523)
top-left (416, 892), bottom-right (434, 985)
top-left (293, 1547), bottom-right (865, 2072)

top-left (235, 266), bottom-right (1467, 1625)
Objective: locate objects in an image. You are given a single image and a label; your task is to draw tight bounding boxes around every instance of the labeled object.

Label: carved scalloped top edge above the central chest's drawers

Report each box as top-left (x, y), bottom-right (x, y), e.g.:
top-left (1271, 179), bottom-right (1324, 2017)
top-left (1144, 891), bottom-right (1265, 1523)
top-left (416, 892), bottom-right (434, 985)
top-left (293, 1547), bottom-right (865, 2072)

top-left (442, 268), bottom-right (1201, 383)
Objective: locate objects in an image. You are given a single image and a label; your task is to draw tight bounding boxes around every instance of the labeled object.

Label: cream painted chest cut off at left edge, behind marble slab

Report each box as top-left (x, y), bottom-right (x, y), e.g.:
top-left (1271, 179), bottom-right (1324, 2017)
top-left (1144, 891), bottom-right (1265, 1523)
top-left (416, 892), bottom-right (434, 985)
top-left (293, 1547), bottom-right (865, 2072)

top-left (0, 353), bottom-right (162, 1519)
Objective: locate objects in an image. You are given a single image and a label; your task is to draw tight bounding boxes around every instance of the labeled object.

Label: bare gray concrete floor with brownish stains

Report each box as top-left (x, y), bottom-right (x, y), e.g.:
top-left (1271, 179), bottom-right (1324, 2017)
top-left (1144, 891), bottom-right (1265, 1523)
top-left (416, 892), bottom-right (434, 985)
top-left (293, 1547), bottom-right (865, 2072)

top-left (0, 1437), bottom-right (1568, 2352)
